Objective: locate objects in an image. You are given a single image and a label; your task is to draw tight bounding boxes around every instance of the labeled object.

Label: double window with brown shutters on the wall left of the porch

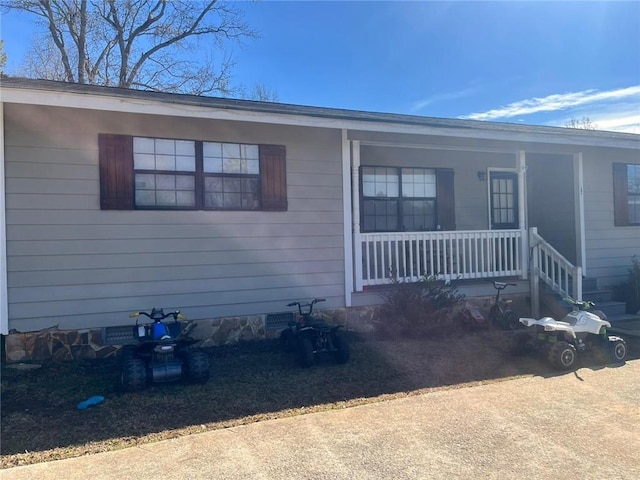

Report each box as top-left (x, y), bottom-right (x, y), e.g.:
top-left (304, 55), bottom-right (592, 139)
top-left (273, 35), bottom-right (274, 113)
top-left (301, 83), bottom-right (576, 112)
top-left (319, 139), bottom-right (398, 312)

top-left (99, 135), bottom-right (287, 210)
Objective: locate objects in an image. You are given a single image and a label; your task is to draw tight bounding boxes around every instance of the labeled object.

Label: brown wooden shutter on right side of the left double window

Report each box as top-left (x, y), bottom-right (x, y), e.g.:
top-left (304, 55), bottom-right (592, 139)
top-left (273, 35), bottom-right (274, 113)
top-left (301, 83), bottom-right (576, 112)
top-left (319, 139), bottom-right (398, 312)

top-left (260, 145), bottom-right (287, 211)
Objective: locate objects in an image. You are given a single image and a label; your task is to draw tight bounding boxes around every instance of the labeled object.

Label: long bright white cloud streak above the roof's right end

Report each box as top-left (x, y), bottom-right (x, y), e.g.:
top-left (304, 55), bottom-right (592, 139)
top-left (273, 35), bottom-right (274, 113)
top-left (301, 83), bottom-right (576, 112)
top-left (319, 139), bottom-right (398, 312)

top-left (461, 85), bottom-right (640, 120)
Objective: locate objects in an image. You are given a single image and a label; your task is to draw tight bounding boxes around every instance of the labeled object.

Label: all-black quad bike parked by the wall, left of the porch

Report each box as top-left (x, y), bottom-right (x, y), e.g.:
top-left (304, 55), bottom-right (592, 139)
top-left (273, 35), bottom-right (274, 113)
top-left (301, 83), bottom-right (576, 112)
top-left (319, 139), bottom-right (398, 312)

top-left (280, 298), bottom-right (350, 368)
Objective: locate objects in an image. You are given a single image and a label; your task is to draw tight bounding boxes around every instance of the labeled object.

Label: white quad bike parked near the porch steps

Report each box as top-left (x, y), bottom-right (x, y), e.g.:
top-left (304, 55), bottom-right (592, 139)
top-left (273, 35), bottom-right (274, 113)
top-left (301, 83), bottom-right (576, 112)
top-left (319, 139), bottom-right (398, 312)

top-left (509, 298), bottom-right (627, 370)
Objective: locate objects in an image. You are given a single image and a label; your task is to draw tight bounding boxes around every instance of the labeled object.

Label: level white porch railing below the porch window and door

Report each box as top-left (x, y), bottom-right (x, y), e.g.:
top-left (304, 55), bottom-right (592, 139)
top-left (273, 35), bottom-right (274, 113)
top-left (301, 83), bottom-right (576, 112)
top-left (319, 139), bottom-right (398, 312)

top-left (355, 230), bottom-right (527, 290)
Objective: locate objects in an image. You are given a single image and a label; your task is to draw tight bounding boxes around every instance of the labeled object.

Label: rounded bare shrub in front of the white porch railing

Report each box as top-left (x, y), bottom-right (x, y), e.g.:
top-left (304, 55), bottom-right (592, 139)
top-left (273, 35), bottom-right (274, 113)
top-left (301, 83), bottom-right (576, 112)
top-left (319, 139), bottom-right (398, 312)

top-left (376, 277), bottom-right (464, 338)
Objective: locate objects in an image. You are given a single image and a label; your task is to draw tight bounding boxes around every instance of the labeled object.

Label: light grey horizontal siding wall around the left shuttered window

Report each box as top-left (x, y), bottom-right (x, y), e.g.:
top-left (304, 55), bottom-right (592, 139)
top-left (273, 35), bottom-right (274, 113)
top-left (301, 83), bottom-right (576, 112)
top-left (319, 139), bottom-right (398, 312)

top-left (5, 105), bottom-right (344, 331)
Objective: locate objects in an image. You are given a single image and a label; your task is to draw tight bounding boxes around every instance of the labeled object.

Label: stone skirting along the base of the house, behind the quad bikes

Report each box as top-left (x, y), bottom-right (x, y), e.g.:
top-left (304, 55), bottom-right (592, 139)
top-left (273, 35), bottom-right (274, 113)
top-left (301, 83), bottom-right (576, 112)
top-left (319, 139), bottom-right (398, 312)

top-left (5, 307), bottom-right (376, 363)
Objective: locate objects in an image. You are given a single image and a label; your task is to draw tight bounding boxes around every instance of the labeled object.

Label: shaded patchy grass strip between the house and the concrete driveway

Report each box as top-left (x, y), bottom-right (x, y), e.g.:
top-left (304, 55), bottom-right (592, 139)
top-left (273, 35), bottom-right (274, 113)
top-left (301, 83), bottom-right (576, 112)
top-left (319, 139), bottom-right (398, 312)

top-left (0, 331), bottom-right (640, 468)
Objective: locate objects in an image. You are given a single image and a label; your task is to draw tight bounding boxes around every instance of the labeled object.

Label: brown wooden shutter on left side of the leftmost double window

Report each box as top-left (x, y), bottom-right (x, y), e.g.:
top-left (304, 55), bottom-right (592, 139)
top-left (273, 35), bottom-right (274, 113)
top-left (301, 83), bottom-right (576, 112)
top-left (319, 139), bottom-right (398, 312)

top-left (98, 134), bottom-right (133, 210)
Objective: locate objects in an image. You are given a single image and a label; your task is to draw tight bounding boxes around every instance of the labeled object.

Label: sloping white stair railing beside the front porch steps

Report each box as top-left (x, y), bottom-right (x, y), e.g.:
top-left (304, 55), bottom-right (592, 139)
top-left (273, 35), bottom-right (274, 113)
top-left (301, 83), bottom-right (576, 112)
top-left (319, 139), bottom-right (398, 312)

top-left (529, 227), bottom-right (582, 300)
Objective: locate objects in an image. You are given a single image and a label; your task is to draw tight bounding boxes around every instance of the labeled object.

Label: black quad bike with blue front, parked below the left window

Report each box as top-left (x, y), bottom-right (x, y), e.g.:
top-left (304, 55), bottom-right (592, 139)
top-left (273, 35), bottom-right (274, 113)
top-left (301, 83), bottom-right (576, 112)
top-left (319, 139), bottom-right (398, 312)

top-left (120, 308), bottom-right (210, 391)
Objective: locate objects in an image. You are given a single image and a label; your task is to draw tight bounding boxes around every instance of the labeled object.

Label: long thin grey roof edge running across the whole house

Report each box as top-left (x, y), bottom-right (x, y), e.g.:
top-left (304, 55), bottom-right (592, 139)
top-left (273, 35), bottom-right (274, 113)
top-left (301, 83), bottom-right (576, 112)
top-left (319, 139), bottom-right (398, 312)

top-left (0, 76), bottom-right (640, 142)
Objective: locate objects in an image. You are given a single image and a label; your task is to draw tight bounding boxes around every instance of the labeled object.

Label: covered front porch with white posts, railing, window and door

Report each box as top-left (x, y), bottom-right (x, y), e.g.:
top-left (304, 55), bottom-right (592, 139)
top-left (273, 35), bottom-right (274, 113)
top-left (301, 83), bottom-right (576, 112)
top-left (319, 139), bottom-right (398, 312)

top-left (344, 131), bottom-right (583, 314)
